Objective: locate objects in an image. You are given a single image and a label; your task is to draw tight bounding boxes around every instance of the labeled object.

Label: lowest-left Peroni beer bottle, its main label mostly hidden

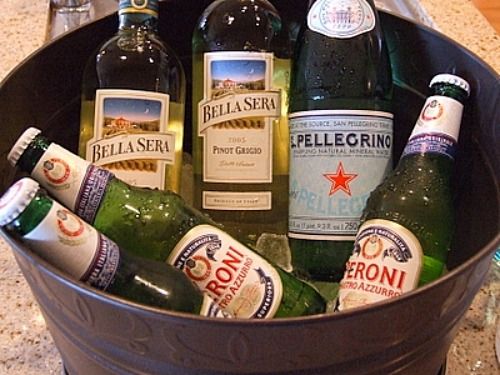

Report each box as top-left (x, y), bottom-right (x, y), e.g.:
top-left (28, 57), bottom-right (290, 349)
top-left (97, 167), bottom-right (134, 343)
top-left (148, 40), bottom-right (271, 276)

top-left (0, 178), bottom-right (228, 317)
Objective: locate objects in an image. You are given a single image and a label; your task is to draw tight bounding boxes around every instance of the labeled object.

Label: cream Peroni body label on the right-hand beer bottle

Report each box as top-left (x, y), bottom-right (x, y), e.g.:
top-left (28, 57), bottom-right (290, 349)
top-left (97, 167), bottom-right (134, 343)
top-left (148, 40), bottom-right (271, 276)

top-left (338, 219), bottom-right (424, 310)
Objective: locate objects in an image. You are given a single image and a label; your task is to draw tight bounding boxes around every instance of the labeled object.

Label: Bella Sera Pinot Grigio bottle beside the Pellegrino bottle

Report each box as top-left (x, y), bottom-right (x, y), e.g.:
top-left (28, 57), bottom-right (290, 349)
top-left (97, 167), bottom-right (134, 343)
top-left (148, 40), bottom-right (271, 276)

top-left (192, 0), bottom-right (291, 236)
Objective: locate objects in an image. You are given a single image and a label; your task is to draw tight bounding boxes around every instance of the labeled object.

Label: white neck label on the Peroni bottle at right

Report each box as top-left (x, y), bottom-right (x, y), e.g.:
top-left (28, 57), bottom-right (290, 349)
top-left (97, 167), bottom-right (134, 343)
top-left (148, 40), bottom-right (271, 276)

top-left (403, 95), bottom-right (463, 159)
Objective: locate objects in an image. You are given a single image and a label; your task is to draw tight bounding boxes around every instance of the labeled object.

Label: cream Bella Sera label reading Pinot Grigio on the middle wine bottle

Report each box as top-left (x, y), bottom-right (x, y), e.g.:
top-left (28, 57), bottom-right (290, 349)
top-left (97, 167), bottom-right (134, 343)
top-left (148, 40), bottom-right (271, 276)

top-left (198, 51), bottom-right (281, 210)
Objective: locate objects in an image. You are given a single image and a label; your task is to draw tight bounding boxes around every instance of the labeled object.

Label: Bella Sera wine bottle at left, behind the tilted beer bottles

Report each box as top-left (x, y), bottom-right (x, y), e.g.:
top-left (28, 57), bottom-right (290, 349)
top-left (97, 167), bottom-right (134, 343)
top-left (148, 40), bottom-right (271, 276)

top-left (79, 0), bottom-right (186, 191)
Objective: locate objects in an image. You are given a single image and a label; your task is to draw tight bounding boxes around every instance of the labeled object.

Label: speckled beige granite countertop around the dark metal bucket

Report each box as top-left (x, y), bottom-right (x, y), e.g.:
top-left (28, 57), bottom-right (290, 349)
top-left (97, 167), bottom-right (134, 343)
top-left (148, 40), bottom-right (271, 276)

top-left (0, 0), bottom-right (500, 375)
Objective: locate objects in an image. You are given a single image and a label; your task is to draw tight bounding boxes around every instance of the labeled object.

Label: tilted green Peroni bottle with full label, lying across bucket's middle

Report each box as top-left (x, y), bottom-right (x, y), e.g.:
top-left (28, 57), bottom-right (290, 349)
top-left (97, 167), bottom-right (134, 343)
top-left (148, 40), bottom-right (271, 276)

top-left (8, 128), bottom-right (325, 319)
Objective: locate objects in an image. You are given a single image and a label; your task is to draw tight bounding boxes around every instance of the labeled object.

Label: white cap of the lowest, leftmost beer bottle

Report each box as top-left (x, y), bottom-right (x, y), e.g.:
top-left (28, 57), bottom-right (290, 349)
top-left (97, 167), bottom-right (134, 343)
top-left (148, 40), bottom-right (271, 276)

top-left (0, 177), bottom-right (40, 226)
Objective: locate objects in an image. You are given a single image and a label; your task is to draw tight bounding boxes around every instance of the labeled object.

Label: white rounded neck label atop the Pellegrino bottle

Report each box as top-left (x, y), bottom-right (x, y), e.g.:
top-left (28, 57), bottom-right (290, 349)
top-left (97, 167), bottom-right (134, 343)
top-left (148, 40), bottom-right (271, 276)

top-left (307, 0), bottom-right (376, 39)
